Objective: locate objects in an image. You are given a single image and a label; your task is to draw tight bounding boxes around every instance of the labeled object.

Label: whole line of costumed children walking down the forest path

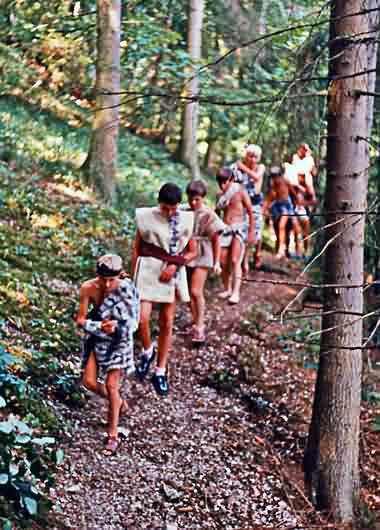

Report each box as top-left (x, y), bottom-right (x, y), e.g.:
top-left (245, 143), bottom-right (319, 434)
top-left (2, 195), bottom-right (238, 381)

top-left (77, 144), bottom-right (315, 454)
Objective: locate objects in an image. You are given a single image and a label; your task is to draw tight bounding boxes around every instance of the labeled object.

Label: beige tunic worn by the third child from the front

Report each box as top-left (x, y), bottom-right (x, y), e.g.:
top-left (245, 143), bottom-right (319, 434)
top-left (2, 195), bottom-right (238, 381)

top-left (183, 206), bottom-right (226, 269)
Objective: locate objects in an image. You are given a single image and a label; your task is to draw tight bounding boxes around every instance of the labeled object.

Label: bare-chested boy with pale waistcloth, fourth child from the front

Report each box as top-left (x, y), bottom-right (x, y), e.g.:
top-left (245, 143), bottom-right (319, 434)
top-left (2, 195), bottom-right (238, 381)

top-left (216, 168), bottom-right (255, 304)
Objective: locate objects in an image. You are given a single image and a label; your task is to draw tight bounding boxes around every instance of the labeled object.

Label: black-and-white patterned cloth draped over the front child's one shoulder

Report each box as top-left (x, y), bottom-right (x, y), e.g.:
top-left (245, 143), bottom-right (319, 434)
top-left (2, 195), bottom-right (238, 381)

top-left (82, 279), bottom-right (140, 375)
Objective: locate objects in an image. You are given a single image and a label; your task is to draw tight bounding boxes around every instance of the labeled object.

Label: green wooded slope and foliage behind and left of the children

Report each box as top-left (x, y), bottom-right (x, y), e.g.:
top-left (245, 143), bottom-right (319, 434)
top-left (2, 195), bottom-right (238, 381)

top-left (0, 0), bottom-right (380, 529)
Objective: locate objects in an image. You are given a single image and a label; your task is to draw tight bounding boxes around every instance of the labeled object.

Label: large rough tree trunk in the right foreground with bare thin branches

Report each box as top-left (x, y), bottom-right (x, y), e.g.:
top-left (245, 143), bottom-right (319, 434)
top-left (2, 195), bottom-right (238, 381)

top-left (304, 0), bottom-right (380, 523)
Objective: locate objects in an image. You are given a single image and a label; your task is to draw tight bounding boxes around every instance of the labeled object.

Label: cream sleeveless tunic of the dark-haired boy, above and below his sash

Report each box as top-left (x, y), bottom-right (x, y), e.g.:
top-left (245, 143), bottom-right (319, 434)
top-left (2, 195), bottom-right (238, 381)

top-left (134, 206), bottom-right (194, 303)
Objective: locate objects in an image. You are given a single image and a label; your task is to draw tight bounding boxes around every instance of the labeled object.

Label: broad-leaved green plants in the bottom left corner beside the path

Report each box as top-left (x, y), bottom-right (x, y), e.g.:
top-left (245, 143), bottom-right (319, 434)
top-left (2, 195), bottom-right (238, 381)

top-left (0, 347), bottom-right (58, 520)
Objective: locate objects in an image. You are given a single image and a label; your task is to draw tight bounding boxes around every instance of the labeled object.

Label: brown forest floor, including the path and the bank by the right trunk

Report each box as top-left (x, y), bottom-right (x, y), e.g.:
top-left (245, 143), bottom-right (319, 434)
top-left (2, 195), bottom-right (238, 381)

top-left (50, 255), bottom-right (380, 530)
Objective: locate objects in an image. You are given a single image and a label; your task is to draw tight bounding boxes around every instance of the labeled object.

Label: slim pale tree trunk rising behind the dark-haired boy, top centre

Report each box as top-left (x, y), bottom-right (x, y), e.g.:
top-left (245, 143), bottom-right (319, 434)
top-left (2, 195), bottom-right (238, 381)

top-left (180, 0), bottom-right (204, 179)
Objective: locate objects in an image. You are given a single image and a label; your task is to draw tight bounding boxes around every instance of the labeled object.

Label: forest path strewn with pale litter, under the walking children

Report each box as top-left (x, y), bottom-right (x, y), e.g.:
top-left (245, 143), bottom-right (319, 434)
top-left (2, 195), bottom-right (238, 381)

top-left (53, 254), bottom-right (314, 530)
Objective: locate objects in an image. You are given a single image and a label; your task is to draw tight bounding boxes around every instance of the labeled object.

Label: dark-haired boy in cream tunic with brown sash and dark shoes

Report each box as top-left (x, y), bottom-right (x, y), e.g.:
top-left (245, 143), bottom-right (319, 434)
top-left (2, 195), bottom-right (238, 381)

top-left (132, 183), bottom-right (196, 396)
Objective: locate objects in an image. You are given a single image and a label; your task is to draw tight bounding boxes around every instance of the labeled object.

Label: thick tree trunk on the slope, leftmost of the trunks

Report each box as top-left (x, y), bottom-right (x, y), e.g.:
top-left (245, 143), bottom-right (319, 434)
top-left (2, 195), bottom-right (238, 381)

top-left (83, 0), bottom-right (121, 201)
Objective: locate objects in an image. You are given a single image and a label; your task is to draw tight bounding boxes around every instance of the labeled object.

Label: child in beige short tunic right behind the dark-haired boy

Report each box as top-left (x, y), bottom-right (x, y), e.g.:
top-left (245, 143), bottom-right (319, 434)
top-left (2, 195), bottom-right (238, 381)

top-left (186, 180), bottom-right (225, 343)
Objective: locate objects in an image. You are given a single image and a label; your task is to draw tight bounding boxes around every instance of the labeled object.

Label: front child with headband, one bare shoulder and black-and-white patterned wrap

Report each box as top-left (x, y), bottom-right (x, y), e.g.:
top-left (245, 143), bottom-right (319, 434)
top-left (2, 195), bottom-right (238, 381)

top-left (77, 254), bottom-right (139, 454)
